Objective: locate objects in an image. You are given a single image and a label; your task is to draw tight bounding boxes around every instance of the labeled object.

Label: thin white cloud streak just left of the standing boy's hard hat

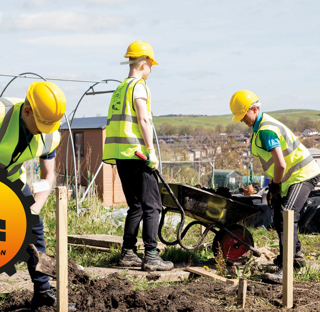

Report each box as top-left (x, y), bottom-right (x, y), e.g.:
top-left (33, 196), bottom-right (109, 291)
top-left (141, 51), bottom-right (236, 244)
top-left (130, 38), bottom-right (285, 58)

top-left (21, 34), bottom-right (132, 50)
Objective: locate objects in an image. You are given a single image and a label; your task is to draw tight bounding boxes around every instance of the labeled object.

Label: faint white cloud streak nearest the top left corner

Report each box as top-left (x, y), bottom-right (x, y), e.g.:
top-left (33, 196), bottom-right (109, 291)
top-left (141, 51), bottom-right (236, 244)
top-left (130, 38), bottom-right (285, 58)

top-left (0, 11), bottom-right (128, 32)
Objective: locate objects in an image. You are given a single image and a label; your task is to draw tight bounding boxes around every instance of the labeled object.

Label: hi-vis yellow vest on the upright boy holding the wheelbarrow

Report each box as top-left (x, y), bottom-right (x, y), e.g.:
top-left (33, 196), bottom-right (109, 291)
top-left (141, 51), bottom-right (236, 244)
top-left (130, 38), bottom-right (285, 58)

top-left (102, 77), bottom-right (152, 165)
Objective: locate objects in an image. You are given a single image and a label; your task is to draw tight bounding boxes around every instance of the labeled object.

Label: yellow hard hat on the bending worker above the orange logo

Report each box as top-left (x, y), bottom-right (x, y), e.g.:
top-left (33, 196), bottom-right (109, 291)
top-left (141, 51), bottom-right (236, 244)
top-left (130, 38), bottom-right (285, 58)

top-left (27, 81), bottom-right (67, 133)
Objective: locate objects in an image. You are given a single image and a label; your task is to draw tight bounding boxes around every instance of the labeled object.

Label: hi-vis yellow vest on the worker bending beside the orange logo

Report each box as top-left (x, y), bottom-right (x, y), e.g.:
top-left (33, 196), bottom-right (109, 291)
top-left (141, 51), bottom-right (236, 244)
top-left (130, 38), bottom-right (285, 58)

top-left (0, 98), bottom-right (60, 183)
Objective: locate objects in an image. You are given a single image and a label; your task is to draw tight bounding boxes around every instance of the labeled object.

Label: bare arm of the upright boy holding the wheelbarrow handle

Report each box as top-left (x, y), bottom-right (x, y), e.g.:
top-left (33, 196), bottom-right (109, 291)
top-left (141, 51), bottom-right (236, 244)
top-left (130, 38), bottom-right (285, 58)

top-left (135, 98), bottom-right (153, 148)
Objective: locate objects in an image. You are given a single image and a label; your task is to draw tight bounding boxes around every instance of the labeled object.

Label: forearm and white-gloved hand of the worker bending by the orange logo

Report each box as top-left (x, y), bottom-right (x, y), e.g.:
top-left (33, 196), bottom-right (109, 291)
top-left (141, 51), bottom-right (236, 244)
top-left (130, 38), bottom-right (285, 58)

top-left (31, 158), bottom-right (55, 213)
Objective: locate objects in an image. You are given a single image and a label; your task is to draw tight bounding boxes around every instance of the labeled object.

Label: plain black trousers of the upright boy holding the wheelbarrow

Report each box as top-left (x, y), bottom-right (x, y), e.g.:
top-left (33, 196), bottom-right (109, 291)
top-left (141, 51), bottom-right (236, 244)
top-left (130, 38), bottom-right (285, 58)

top-left (116, 159), bottom-right (162, 251)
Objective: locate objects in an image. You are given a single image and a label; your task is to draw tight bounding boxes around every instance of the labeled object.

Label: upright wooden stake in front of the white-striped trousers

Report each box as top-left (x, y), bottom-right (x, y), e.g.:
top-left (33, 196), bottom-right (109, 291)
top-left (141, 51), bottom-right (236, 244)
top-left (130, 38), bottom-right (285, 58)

top-left (283, 210), bottom-right (294, 308)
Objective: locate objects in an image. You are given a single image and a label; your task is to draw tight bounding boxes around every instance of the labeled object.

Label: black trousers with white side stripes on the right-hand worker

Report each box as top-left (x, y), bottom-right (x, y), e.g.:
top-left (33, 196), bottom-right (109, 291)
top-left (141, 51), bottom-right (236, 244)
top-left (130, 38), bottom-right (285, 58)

top-left (274, 175), bottom-right (320, 263)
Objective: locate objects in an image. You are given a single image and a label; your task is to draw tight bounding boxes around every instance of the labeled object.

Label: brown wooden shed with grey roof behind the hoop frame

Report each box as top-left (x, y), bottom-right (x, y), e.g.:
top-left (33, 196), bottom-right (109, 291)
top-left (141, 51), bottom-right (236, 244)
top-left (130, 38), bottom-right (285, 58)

top-left (56, 116), bottom-right (126, 206)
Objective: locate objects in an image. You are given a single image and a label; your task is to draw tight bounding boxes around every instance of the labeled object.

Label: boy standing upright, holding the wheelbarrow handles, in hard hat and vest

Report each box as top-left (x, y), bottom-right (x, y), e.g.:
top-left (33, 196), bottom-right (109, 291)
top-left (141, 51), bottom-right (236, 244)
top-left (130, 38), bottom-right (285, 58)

top-left (103, 41), bottom-right (173, 271)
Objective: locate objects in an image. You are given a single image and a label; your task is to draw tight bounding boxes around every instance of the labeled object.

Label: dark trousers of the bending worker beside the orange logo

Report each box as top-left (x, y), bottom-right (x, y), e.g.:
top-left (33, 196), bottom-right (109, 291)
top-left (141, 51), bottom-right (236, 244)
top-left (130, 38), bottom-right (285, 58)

top-left (22, 184), bottom-right (50, 292)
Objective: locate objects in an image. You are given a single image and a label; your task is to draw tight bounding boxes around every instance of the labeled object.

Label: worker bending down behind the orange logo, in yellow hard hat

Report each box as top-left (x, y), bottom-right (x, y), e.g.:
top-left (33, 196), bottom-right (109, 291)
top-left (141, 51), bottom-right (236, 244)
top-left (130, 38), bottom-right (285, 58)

top-left (0, 81), bottom-right (72, 310)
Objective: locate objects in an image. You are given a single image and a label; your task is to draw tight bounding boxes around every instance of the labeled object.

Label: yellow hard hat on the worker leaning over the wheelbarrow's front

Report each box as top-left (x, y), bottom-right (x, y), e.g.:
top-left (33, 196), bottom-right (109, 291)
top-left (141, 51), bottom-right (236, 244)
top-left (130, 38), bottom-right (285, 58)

top-left (230, 90), bottom-right (259, 122)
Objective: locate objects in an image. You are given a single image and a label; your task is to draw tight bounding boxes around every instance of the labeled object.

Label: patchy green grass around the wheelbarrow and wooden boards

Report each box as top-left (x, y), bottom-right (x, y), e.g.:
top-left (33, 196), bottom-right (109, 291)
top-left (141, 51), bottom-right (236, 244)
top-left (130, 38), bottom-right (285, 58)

top-left (28, 194), bottom-right (320, 289)
